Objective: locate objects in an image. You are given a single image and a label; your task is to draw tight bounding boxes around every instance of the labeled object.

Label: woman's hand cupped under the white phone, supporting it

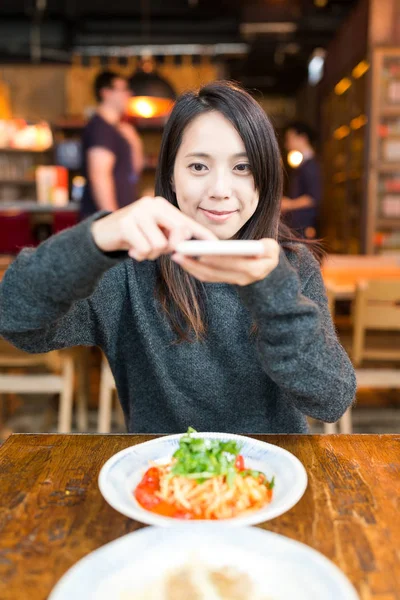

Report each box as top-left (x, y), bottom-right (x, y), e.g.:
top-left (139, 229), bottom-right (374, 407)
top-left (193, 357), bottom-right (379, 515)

top-left (172, 239), bottom-right (279, 285)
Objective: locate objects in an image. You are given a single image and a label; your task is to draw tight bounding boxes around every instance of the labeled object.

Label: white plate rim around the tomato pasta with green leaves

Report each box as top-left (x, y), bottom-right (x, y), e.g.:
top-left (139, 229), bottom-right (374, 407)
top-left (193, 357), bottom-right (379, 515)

top-left (99, 433), bottom-right (307, 527)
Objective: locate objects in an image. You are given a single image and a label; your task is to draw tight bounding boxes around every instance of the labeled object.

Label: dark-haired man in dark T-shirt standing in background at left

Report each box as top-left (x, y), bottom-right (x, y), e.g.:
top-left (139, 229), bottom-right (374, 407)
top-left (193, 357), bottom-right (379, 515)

top-left (81, 71), bottom-right (143, 218)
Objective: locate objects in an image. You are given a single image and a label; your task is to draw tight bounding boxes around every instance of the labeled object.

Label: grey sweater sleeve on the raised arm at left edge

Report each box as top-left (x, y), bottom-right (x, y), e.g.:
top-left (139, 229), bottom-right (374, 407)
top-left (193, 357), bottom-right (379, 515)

top-left (0, 213), bottom-right (126, 353)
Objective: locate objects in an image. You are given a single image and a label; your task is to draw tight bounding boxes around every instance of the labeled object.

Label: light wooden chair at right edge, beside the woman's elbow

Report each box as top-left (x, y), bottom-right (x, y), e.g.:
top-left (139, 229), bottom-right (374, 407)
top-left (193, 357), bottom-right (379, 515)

top-left (325, 280), bottom-right (400, 433)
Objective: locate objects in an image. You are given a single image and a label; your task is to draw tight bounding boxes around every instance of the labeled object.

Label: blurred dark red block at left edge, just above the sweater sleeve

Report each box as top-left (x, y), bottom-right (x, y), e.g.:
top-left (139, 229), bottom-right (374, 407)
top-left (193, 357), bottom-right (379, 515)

top-left (0, 211), bottom-right (37, 254)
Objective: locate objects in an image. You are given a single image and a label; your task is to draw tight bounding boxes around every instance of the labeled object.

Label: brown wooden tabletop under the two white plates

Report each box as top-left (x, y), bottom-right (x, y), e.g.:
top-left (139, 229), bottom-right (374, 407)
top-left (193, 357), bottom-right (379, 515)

top-left (0, 434), bottom-right (400, 600)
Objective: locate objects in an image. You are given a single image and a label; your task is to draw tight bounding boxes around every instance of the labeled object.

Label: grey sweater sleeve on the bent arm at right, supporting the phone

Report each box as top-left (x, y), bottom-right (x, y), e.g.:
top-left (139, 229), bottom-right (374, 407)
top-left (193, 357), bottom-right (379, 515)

top-left (239, 250), bottom-right (356, 422)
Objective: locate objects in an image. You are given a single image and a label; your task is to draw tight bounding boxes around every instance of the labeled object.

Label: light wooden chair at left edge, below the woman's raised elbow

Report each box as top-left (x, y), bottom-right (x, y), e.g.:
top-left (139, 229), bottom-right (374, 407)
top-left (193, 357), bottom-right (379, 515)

top-left (0, 340), bottom-right (87, 433)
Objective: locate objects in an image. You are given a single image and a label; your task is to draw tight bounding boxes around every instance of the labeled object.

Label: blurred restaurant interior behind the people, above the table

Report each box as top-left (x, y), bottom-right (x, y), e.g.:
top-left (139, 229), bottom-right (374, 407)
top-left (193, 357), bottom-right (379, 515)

top-left (0, 0), bottom-right (400, 439)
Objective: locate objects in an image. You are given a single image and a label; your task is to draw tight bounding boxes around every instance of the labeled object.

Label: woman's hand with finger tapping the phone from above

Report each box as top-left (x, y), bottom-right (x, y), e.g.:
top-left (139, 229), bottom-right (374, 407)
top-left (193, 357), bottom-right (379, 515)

top-left (92, 197), bottom-right (217, 261)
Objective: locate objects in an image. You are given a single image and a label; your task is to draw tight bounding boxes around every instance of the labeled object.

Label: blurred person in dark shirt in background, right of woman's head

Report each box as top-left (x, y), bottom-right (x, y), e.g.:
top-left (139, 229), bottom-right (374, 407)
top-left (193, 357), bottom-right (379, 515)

top-left (281, 122), bottom-right (322, 239)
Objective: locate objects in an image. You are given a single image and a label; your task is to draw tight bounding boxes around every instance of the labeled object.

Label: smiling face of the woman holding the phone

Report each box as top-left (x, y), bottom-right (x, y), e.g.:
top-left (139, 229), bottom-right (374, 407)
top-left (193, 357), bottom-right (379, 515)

top-left (173, 111), bottom-right (258, 240)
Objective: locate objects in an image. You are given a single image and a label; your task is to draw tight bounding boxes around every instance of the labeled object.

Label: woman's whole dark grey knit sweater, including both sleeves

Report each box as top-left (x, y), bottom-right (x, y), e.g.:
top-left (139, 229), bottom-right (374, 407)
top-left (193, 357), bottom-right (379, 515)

top-left (0, 215), bottom-right (355, 433)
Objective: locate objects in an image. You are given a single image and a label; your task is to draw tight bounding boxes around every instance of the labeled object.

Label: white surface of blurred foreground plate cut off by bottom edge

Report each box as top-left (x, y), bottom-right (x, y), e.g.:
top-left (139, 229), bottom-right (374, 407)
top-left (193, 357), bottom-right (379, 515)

top-left (48, 523), bottom-right (358, 600)
